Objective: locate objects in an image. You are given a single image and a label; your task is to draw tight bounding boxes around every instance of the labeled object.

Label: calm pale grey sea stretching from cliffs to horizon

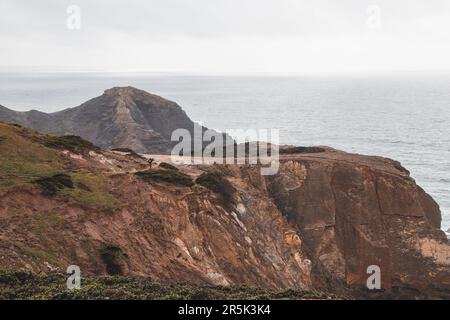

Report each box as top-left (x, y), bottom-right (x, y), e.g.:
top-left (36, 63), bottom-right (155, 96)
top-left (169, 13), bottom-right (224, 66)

top-left (0, 73), bottom-right (450, 230)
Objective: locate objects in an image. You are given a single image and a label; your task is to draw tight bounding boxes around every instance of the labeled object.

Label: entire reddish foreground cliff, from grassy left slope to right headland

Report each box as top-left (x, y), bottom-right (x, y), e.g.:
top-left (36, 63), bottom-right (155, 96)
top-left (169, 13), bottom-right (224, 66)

top-left (0, 124), bottom-right (450, 298)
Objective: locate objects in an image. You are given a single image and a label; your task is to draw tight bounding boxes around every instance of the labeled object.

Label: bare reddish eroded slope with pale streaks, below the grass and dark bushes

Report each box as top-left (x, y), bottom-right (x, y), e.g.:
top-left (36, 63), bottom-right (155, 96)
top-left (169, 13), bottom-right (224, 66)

top-left (0, 162), bottom-right (312, 290)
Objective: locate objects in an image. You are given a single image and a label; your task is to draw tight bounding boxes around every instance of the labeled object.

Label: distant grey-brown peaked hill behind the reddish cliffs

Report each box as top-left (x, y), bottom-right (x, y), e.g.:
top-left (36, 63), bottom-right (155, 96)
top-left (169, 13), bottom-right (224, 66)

top-left (0, 87), bottom-right (220, 154)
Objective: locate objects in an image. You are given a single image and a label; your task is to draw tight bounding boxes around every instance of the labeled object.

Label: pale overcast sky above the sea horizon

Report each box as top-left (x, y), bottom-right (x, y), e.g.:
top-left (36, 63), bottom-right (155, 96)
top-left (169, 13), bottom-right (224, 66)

top-left (0, 0), bottom-right (450, 74)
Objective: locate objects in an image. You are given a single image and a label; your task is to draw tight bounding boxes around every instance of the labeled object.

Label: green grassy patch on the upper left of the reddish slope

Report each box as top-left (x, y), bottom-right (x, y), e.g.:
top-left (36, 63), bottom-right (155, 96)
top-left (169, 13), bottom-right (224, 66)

top-left (0, 123), bottom-right (115, 209)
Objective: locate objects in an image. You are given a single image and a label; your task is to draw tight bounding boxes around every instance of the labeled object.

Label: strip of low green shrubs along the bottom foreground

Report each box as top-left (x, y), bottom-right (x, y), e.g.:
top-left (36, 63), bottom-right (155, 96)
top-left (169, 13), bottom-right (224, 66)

top-left (0, 272), bottom-right (337, 300)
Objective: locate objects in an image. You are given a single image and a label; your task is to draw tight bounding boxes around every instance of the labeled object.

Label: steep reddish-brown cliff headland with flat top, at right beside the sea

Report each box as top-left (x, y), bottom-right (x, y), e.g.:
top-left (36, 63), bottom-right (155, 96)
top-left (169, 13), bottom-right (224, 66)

top-left (268, 150), bottom-right (450, 296)
